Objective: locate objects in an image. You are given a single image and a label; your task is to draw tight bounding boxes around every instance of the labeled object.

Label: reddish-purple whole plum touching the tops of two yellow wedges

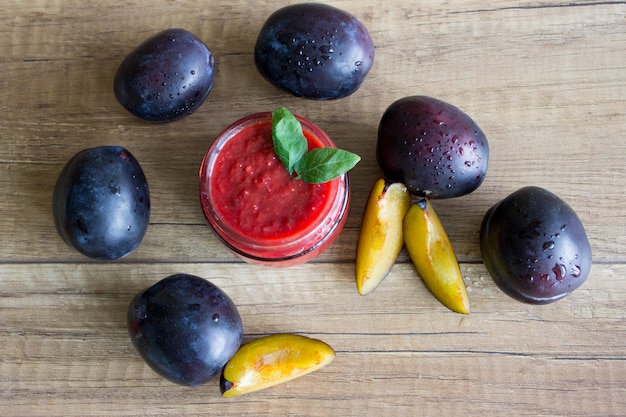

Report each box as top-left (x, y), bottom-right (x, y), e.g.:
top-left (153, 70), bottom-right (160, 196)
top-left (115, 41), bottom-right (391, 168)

top-left (376, 96), bottom-right (489, 198)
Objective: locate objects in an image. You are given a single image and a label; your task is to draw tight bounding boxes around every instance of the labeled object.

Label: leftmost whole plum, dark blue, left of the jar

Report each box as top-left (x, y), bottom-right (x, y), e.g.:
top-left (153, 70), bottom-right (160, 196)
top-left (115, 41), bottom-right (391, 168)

top-left (52, 146), bottom-right (150, 260)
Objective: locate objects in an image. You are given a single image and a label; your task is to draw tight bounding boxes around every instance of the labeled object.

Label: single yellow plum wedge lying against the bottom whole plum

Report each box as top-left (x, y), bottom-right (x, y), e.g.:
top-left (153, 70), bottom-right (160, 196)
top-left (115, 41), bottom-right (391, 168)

top-left (220, 334), bottom-right (335, 398)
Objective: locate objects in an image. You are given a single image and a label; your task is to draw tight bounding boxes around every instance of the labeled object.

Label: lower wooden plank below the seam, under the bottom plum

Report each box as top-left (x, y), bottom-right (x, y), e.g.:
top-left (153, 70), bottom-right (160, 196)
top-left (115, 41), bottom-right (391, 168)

top-left (0, 263), bottom-right (626, 416)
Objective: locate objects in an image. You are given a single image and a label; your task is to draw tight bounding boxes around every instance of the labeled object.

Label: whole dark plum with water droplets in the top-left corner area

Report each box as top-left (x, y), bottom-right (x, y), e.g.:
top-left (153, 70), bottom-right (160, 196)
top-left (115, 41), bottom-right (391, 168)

top-left (113, 29), bottom-right (215, 123)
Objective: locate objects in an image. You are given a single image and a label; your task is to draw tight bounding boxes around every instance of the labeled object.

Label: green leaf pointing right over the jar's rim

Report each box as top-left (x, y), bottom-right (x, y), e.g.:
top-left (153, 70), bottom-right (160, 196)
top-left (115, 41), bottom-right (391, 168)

top-left (295, 148), bottom-right (361, 184)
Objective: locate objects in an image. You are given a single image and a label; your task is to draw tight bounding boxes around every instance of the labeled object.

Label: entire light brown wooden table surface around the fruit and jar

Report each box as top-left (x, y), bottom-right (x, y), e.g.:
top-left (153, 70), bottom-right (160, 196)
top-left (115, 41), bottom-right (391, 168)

top-left (0, 0), bottom-right (626, 417)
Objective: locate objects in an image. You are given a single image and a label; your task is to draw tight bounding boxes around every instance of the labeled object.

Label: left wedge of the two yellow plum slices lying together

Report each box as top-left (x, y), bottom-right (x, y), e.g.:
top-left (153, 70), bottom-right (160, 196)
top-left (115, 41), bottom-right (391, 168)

top-left (356, 178), bottom-right (411, 295)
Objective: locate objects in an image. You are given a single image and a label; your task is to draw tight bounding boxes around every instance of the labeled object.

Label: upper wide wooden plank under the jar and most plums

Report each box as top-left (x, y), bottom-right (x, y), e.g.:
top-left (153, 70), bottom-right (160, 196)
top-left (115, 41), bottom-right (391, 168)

top-left (0, 2), bottom-right (626, 261)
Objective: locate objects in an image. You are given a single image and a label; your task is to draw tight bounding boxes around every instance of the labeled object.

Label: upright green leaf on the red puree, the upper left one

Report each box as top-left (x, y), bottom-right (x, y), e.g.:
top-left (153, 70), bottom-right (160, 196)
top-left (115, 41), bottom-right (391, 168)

top-left (272, 107), bottom-right (308, 175)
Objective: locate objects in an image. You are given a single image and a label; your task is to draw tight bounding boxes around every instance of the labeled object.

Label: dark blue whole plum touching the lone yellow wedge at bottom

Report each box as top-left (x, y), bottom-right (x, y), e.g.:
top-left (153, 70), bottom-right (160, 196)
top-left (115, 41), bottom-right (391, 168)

top-left (128, 274), bottom-right (243, 386)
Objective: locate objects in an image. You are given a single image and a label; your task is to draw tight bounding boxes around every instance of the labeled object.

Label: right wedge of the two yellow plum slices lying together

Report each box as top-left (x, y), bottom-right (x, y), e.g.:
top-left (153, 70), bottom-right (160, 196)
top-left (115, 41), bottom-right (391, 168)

top-left (404, 199), bottom-right (469, 314)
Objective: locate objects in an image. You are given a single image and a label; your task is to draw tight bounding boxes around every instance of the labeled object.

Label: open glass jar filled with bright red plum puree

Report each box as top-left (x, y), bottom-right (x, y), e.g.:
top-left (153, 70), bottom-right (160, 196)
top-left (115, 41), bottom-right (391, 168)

top-left (200, 112), bottom-right (350, 267)
